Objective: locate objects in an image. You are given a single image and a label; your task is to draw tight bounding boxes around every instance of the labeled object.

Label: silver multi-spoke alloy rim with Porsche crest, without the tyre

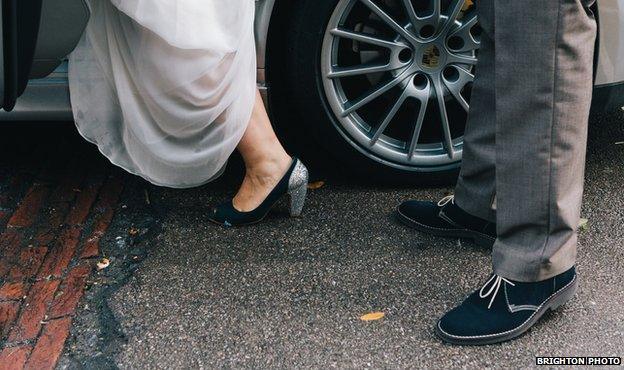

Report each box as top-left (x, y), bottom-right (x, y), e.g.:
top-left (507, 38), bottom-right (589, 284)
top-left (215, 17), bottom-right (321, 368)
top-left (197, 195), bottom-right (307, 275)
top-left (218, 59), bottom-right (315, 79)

top-left (321, 0), bottom-right (480, 171)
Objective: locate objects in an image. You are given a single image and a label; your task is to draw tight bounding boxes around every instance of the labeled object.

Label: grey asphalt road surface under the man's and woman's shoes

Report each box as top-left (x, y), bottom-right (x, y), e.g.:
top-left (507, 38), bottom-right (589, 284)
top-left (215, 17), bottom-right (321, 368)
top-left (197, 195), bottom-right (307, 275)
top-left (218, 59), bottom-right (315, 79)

top-left (36, 112), bottom-right (624, 368)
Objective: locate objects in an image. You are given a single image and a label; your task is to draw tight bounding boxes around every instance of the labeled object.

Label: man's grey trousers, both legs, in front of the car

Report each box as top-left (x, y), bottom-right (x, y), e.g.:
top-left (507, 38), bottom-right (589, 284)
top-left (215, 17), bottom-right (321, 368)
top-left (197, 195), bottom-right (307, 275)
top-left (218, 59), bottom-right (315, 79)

top-left (455, 0), bottom-right (596, 282)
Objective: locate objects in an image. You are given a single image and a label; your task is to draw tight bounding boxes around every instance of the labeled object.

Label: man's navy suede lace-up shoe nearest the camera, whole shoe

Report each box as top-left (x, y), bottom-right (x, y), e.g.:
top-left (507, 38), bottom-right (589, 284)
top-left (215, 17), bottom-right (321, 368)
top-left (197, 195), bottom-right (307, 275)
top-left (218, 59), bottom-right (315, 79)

top-left (436, 267), bottom-right (578, 345)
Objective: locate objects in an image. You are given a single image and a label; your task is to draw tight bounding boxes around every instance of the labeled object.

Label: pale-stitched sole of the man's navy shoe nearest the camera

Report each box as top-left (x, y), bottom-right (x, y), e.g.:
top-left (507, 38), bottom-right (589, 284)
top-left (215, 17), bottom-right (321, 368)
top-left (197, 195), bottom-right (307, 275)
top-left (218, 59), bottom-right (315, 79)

top-left (436, 276), bottom-right (578, 346)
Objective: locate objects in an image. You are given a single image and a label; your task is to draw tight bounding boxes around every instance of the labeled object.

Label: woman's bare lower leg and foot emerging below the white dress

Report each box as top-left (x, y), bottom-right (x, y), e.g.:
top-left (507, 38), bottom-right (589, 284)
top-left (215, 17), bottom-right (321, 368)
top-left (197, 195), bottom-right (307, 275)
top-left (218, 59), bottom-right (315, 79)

top-left (233, 92), bottom-right (291, 212)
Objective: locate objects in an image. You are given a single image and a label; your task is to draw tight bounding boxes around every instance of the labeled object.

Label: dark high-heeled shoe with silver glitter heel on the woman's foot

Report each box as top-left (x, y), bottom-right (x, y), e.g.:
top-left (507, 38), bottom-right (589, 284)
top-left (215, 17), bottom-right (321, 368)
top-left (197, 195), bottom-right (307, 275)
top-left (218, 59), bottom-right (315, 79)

top-left (209, 158), bottom-right (308, 226)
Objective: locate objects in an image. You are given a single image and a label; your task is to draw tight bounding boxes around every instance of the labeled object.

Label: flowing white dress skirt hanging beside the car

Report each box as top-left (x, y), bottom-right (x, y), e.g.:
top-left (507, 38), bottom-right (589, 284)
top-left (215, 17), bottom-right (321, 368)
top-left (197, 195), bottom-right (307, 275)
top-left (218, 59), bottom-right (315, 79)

top-left (69, 0), bottom-right (256, 188)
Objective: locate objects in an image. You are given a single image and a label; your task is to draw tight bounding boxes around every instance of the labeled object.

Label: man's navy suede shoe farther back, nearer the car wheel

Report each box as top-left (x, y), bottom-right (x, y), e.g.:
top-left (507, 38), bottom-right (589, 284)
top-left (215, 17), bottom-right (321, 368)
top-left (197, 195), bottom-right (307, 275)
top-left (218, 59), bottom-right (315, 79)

top-left (397, 195), bottom-right (496, 248)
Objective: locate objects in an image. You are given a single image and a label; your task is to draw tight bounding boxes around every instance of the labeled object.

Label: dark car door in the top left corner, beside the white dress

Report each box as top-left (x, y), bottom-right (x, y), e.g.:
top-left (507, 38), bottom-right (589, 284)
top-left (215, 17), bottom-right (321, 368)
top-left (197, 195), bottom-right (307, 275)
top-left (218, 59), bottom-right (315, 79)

top-left (0, 0), bottom-right (89, 111)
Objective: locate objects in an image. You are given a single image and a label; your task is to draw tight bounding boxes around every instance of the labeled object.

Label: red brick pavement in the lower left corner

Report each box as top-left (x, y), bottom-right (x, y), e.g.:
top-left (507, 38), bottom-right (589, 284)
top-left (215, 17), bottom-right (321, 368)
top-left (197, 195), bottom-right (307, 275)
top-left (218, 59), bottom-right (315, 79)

top-left (0, 145), bottom-right (123, 370)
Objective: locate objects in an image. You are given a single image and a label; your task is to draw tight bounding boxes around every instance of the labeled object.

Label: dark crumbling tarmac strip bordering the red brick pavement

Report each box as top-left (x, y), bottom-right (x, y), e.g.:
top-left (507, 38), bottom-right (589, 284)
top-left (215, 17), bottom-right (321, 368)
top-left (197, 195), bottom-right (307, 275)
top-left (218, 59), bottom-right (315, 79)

top-left (57, 175), bottom-right (162, 369)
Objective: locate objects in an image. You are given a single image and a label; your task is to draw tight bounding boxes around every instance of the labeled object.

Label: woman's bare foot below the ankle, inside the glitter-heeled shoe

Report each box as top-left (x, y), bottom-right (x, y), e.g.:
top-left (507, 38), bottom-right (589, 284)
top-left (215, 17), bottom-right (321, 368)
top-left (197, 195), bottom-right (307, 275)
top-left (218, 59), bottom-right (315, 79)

top-left (232, 155), bottom-right (292, 212)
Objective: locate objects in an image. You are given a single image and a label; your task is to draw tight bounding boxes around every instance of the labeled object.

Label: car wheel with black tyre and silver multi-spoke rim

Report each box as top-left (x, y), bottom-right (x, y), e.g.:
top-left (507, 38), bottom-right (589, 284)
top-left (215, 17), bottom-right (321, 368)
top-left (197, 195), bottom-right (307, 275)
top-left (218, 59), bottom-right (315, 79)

top-left (268, 0), bottom-right (479, 182)
